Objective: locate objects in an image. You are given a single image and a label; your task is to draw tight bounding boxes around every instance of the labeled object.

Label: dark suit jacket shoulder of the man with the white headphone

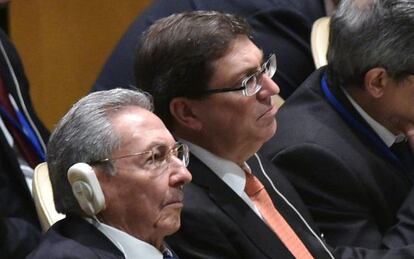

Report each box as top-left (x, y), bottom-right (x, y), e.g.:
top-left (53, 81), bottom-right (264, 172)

top-left (28, 216), bottom-right (124, 259)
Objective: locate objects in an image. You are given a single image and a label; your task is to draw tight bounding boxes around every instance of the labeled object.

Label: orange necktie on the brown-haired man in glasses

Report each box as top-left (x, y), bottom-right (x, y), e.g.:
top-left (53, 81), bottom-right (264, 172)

top-left (244, 168), bottom-right (313, 259)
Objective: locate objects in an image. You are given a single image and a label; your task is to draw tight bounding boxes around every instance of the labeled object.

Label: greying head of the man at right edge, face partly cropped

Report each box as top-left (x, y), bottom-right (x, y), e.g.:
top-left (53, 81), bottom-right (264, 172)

top-left (327, 0), bottom-right (414, 132)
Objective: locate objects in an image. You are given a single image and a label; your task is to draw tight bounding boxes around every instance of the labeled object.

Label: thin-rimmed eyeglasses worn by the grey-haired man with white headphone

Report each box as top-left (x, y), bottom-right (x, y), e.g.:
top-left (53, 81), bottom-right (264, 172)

top-left (91, 142), bottom-right (190, 170)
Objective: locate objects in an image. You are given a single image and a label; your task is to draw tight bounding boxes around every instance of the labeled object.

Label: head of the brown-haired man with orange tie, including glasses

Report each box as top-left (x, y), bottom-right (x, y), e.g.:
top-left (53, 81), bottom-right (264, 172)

top-left (135, 11), bottom-right (279, 165)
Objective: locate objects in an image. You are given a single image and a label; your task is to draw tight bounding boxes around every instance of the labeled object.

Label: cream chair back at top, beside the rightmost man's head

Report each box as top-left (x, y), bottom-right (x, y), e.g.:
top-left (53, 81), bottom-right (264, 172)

top-left (311, 16), bottom-right (331, 68)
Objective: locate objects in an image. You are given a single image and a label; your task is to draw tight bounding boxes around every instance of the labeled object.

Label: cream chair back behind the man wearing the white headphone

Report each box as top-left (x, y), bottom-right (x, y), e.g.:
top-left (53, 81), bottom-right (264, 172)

top-left (33, 162), bottom-right (65, 231)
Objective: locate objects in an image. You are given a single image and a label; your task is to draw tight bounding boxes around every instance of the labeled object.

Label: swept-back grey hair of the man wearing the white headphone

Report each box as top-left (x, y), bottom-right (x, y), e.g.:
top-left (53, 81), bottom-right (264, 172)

top-left (47, 88), bottom-right (152, 215)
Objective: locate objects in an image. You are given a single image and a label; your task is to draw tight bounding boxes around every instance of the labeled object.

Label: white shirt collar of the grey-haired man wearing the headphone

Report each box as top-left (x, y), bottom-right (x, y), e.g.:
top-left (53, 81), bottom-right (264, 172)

top-left (85, 218), bottom-right (165, 259)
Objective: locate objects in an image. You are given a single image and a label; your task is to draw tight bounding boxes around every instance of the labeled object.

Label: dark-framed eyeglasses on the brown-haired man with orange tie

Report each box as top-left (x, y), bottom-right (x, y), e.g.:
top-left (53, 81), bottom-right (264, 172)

top-left (204, 54), bottom-right (277, 96)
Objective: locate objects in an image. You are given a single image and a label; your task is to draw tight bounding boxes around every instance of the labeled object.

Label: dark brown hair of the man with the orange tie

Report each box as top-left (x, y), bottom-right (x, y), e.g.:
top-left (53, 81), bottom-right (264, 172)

top-left (135, 11), bottom-right (251, 129)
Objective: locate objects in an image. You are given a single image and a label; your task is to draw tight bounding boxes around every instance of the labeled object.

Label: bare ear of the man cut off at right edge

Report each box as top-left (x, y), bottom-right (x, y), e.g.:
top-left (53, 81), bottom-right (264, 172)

top-left (364, 67), bottom-right (390, 98)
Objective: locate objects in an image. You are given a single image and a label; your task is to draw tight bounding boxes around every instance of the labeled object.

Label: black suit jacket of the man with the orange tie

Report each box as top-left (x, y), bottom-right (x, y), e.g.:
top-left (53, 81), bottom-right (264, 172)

top-left (167, 153), bottom-right (328, 259)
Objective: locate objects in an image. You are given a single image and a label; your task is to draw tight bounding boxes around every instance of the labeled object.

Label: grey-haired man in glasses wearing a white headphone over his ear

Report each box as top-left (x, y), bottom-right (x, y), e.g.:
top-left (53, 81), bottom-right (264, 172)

top-left (29, 89), bottom-right (191, 259)
